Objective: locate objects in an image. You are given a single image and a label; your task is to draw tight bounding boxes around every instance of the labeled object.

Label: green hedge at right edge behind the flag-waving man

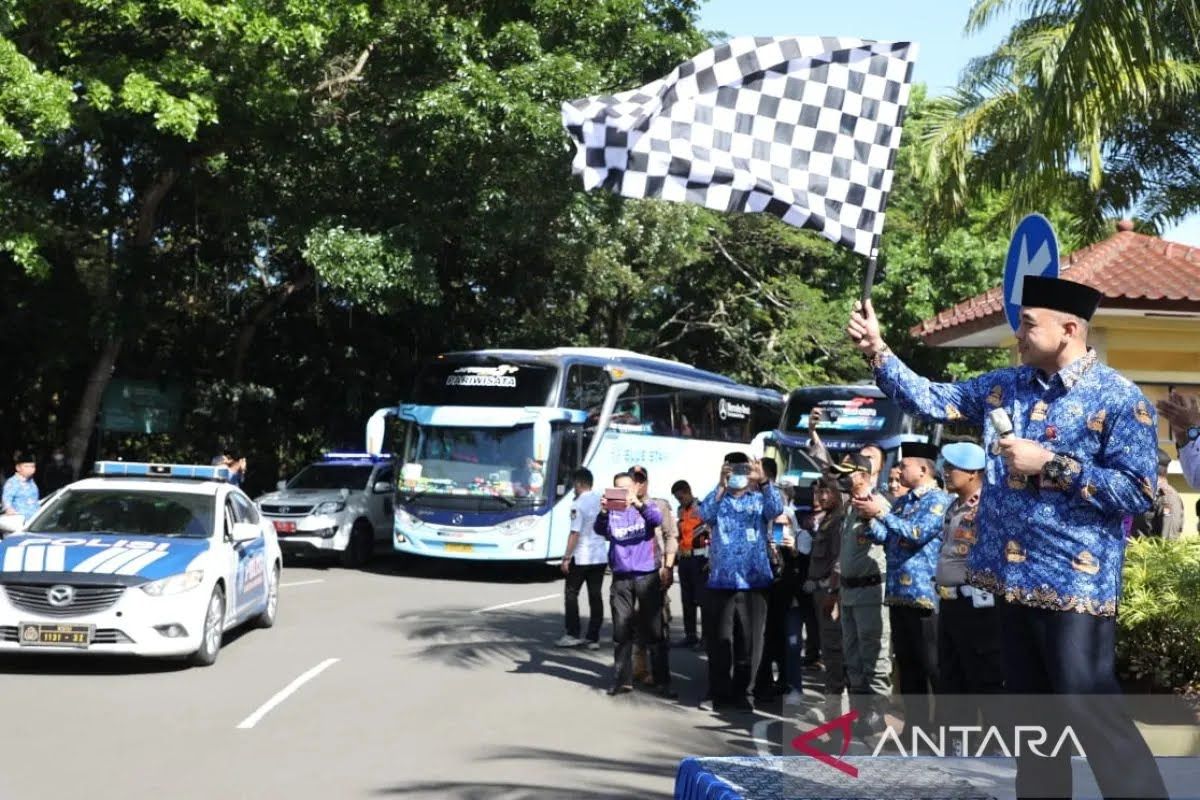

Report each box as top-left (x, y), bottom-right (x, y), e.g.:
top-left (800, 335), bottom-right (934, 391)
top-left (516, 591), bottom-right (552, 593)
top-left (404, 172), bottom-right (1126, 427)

top-left (1117, 537), bottom-right (1200, 696)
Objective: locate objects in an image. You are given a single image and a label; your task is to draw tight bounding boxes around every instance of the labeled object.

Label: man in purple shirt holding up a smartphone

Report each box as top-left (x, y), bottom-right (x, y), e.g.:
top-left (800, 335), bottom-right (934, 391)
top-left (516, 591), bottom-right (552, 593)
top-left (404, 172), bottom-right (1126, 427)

top-left (595, 473), bottom-right (676, 698)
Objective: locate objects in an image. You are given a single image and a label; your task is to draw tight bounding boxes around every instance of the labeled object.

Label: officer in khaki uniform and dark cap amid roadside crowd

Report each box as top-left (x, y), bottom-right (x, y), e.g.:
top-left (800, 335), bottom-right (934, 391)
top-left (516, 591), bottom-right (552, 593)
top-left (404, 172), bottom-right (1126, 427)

top-left (833, 453), bottom-right (892, 739)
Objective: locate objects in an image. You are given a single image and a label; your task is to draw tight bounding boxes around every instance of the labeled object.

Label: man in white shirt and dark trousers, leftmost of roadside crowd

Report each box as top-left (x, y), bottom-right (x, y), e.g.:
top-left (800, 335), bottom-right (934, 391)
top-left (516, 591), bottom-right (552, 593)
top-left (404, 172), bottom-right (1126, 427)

top-left (554, 468), bottom-right (608, 650)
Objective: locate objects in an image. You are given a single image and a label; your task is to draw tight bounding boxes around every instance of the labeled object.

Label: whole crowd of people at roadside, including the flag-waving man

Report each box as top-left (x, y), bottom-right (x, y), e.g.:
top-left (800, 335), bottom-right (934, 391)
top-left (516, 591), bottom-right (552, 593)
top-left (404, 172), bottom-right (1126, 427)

top-left (558, 277), bottom-right (1200, 798)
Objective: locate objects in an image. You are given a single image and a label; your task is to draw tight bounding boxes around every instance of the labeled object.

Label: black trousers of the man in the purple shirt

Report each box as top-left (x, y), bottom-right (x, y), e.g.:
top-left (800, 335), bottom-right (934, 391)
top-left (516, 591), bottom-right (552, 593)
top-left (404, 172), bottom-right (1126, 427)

top-left (608, 572), bottom-right (671, 686)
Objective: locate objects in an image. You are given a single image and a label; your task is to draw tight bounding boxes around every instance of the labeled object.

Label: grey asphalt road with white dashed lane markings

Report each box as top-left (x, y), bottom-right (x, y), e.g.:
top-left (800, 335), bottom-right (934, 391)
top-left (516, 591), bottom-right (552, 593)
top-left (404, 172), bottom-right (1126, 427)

top-left (0, 557), bottom-right (770, 800)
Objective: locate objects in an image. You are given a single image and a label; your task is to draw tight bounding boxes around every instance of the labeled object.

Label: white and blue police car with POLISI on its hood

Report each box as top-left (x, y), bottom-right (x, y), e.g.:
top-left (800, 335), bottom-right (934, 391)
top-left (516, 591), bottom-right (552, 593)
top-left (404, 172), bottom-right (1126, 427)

top-left (0, 462), bottom-right (282, 666)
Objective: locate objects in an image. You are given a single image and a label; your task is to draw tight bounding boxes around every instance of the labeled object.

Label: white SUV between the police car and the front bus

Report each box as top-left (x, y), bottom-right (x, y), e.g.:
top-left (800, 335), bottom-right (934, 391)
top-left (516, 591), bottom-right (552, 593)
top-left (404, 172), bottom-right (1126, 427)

top-left (254, 453), bottom-right (396, 567)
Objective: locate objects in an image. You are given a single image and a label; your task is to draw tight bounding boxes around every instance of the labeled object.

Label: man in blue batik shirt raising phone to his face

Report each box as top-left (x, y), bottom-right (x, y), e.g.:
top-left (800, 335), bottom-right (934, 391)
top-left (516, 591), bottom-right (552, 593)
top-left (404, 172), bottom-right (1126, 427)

top-left (700, 452), bottom-right (784, 710)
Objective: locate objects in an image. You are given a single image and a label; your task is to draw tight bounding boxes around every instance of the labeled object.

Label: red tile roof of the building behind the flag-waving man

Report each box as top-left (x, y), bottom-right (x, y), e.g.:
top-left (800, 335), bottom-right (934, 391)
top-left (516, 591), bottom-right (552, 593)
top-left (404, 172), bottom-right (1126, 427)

top-left (911, 222), bottom-right (1200, 344)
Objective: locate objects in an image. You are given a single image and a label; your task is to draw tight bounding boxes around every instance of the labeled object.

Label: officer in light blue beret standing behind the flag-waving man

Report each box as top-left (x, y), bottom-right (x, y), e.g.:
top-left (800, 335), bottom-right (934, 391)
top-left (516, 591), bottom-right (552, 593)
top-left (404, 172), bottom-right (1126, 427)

top-left (936, 441), bottom-right (1004, 754)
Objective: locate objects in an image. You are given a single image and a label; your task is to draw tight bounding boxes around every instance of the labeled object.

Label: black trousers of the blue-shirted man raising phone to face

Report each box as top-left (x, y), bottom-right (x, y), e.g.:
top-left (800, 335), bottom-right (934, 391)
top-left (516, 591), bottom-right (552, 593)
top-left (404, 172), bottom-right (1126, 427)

top-left (706, 589), bottom-right (767, 703)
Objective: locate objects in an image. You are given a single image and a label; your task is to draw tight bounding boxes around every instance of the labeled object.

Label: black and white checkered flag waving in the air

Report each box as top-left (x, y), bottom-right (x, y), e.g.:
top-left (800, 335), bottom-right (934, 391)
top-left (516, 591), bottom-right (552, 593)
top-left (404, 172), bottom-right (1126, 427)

top-left (563, 36), bottom-right (917, 255)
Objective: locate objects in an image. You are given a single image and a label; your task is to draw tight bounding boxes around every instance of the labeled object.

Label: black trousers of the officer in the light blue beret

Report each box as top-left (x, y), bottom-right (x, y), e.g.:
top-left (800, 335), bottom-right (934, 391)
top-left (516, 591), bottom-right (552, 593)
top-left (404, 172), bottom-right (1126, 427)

top-left (937, 597), bottom-right (1004, 728)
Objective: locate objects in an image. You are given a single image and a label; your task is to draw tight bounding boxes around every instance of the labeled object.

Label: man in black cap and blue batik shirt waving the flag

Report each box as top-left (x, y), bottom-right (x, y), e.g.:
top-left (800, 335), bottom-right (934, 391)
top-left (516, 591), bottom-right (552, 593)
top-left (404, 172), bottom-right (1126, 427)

top-left (846, 277), bottom-right (1166, 798)
